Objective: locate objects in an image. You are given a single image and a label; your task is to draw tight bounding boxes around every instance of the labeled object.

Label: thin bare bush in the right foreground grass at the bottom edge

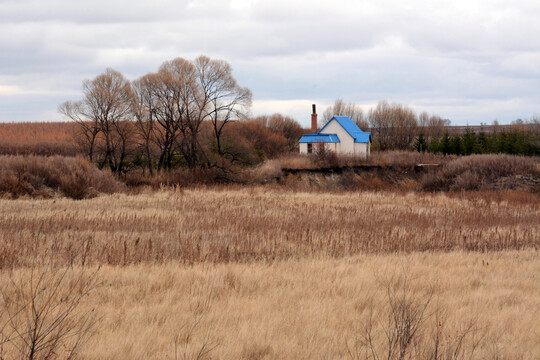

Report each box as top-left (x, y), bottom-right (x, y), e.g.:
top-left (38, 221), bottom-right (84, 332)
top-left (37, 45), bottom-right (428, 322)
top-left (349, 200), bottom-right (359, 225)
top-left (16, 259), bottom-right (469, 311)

top-left (346, 276), bottom-right (483, 360)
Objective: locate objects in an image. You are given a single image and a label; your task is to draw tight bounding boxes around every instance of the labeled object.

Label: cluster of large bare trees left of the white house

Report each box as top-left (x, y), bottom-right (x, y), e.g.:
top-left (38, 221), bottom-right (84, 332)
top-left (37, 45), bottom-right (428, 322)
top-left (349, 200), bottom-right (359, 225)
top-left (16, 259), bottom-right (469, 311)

top-left (59, 56), bottom-right (258, 172)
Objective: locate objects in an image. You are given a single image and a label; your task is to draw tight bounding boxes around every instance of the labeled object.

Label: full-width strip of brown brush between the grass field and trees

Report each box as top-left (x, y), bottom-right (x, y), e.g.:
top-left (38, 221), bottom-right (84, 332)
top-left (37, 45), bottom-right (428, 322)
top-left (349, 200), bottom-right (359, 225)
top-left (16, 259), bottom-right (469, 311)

top-left (0, 151), bottom-right (540, 199)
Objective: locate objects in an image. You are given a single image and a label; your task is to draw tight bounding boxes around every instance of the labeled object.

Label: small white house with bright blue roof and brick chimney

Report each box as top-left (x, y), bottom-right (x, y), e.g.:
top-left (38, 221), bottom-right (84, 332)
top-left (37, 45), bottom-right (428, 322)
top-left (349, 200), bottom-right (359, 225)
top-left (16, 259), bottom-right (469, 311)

top-left (299, 105), bottom-right (372, 157)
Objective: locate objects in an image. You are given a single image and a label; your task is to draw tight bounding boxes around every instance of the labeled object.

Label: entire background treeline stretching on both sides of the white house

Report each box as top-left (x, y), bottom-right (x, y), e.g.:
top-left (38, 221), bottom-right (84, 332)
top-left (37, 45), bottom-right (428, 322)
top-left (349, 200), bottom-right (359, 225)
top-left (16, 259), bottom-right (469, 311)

top-left (0, 90), bottom-right (540, 176)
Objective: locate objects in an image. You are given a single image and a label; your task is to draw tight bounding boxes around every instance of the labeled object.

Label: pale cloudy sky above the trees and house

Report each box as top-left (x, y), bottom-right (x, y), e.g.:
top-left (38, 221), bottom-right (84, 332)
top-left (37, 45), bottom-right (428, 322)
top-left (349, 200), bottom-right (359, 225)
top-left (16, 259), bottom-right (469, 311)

top-left (0, 0), bottom-right (540, 127)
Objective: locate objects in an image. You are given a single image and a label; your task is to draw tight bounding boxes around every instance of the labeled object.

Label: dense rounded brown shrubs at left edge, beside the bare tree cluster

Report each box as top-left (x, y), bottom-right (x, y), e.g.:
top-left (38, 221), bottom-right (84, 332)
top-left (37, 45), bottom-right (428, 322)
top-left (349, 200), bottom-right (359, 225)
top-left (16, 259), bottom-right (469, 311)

top-left (0, 156), bottom-right (123, 199)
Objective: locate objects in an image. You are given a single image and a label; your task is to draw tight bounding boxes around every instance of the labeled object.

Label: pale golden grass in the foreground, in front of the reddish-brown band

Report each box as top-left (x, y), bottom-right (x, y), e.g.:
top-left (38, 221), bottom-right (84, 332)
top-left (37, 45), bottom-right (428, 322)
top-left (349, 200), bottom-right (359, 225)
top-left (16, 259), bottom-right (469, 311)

top-left (0, 251), bottom-right (540, 359)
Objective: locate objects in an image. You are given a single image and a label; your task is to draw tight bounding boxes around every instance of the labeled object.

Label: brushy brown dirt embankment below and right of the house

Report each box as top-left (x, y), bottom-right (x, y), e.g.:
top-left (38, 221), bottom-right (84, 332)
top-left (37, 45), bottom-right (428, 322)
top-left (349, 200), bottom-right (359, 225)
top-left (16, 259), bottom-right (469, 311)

top-left (276, 155), bottom-right (540, 193)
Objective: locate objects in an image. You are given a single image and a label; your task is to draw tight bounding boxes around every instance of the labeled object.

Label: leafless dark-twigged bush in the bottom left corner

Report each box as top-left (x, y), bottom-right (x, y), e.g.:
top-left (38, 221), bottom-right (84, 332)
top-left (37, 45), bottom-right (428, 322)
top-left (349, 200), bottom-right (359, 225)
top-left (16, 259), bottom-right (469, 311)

top-left (0, 264), bottom-right (97, 360)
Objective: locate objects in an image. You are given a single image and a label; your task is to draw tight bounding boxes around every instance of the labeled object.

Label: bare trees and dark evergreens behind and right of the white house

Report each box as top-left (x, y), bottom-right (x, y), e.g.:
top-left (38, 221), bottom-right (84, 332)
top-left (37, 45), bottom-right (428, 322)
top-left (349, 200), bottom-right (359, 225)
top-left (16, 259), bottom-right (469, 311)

top-left (323, 99), bottom-right (540, 156)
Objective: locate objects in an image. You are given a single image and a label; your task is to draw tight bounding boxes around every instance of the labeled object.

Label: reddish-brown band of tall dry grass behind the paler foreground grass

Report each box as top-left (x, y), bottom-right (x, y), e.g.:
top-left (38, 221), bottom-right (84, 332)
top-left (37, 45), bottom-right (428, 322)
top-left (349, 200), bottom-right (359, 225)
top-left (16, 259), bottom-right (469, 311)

top-left (0, 187), bottom-right (540, 269)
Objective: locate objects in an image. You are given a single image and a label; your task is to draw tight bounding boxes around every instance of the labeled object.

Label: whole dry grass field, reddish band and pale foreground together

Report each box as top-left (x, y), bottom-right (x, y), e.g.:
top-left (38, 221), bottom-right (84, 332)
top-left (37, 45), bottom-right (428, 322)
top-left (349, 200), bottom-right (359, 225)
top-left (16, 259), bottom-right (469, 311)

top-left (0, 186), bottom-right (540, 359)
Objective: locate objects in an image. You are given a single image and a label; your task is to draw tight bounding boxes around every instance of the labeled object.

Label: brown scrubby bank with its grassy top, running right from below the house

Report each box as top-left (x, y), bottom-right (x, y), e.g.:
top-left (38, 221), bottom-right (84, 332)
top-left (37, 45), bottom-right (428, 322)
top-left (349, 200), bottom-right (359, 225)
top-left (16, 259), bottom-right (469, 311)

top-left (274, 151), bottom-right (540, 194)
